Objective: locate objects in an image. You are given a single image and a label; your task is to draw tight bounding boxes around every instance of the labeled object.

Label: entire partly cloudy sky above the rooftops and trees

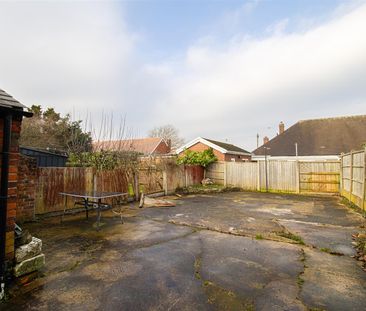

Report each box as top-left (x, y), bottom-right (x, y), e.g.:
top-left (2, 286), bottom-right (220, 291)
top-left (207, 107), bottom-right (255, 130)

top-left (0, 0), bottom-right (366, 151)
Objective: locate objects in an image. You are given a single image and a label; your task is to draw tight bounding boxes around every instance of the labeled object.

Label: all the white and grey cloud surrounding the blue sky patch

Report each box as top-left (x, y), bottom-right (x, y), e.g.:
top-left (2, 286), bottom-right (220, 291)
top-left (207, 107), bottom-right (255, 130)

top-left (0, 2), bottom-right (366, 149)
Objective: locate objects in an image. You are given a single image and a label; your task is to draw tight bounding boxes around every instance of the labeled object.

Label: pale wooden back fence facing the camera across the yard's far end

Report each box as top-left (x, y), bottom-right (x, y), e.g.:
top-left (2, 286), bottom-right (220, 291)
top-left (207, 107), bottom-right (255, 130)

top-left (206, 160), bottom-right (340, 193)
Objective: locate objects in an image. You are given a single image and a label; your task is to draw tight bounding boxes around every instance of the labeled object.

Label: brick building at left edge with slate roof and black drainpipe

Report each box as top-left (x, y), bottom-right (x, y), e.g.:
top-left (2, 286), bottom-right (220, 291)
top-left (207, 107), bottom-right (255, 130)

top-left (0, 89), bottom-right (32, 298)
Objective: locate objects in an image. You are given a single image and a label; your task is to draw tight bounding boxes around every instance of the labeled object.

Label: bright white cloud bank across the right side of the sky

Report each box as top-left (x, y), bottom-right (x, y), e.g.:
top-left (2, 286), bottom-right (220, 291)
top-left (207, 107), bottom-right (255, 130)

top-left (147, 5), bottom-right (366, 148)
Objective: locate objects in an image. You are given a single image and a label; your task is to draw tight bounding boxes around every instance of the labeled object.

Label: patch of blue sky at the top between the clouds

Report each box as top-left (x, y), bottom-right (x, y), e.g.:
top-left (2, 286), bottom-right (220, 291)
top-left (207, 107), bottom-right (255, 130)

top-left (121, 0), bottom-right (345, 59)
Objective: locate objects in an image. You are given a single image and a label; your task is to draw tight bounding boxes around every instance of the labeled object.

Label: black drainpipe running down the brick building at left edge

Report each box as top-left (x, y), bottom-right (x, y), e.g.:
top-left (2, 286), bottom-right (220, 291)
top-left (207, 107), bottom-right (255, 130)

top-left (0, 113), bottom-right (12, 296)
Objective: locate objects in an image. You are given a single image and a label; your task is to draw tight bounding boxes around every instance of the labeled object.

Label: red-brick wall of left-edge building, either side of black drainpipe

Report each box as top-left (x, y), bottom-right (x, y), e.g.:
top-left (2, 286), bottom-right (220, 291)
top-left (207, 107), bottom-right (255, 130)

top-left (0, 116), bottom-right (22, 261)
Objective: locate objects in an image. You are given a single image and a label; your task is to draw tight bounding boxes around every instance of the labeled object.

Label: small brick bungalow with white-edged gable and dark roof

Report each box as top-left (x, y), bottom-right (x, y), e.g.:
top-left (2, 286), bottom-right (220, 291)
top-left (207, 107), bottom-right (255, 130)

top-left (176, 137), bottom-right (251, 162)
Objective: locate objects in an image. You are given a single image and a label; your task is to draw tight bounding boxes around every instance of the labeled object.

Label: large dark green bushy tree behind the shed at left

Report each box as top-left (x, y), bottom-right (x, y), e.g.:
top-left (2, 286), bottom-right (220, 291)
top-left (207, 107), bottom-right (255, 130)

top-left (20, 105), bottom-right (92, 153)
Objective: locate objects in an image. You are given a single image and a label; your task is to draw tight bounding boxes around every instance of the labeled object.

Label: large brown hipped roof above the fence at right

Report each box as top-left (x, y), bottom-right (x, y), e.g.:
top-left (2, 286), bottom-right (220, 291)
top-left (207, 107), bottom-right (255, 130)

top-left (253, 115), bottom-right (366, 156)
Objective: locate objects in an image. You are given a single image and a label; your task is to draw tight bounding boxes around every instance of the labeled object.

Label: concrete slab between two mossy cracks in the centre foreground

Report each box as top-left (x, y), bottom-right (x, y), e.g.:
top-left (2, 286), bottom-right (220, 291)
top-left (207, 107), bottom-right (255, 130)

top-left (200, 231), bottom-right (305, 310)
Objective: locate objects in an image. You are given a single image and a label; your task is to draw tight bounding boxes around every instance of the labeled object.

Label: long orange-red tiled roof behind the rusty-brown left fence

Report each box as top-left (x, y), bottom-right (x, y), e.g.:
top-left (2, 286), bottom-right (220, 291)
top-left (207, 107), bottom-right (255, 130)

top-left (93, 137), bottom-right (166, 155)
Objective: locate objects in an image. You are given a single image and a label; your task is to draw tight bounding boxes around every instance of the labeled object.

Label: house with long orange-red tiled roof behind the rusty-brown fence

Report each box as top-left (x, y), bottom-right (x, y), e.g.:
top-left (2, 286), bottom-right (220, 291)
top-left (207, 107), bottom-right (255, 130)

top-left (93, 137), bottom-right (170, 156)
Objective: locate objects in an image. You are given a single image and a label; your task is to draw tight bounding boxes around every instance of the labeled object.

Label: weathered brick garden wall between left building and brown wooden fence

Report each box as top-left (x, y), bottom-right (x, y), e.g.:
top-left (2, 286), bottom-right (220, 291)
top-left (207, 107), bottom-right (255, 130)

top-left (16, 155), bottom-right (38, 223)
